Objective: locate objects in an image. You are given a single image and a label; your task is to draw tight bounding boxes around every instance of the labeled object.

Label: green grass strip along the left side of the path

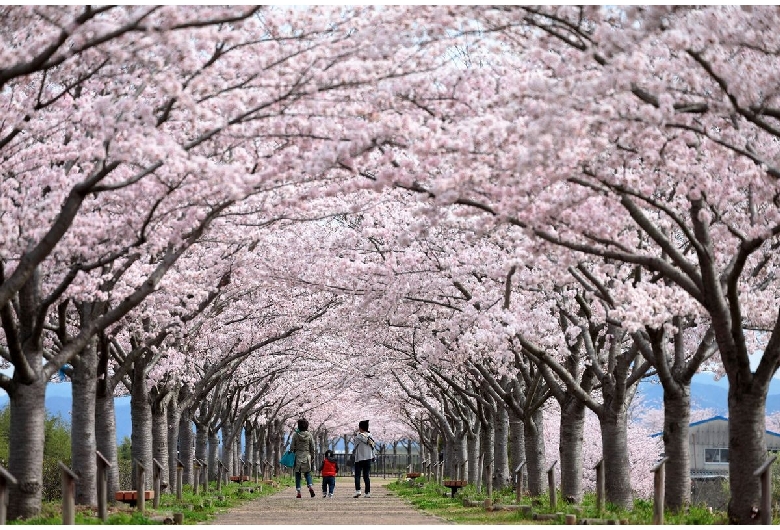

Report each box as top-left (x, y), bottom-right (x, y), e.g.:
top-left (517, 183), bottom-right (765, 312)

top-left (8, 476), bottom-right (293, 525)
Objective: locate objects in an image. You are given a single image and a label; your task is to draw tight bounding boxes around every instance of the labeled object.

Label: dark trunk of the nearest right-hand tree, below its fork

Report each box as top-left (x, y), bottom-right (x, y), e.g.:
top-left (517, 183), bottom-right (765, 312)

top-left (728, 381), bottom-right (767, 524)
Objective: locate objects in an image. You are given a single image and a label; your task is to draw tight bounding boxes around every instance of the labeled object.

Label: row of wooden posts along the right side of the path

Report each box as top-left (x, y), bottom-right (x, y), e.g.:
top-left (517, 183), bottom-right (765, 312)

top-left (406, 455), bottom-right (777, 524)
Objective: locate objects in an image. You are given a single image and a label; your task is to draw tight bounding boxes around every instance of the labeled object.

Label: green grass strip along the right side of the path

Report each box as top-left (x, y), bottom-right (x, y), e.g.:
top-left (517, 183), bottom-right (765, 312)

top-left (388, 478), bottom-right (727, 525)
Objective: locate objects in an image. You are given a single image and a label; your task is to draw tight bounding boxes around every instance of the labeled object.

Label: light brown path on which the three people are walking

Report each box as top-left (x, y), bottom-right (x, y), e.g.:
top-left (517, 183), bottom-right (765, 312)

top-left (208, 477), bottom-right (448, 525)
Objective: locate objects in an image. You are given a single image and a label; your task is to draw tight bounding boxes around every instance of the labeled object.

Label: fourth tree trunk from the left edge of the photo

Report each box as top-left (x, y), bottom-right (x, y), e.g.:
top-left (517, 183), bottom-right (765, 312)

top-left (130, 359), bottom-right (152, 489)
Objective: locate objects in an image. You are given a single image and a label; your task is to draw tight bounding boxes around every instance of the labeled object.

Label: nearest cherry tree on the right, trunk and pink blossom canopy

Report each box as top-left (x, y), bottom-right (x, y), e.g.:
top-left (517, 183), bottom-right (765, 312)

top-left (348, 7), bottom-right (779, 523)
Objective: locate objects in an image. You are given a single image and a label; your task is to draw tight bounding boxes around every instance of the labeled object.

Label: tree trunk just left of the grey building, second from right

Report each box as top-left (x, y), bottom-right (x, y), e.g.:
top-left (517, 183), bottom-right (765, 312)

top-left (663, 381), bottom-right (691, 511)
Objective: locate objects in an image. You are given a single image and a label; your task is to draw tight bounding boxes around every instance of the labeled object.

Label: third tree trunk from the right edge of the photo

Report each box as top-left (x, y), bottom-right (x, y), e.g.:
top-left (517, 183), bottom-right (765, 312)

top-left (599, 407), bottom-right (634, 510)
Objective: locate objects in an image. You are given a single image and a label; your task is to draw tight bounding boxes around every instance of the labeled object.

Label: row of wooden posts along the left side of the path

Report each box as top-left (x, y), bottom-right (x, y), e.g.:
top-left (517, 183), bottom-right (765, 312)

top-left (0, 451), bottom-right (270, 525)
